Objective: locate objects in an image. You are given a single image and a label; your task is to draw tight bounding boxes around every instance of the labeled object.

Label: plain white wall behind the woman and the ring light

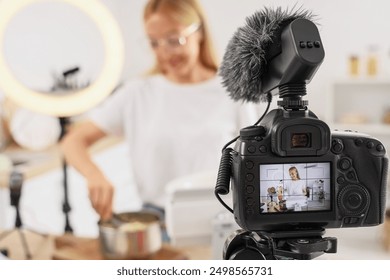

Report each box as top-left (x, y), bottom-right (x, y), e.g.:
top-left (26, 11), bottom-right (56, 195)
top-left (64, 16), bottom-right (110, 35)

top-left (5, 0), bottom-right (390, 118)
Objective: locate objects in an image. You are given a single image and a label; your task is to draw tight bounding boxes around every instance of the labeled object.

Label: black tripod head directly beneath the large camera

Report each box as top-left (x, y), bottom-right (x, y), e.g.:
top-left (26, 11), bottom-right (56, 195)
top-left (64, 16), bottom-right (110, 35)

top-left (223, 228), bottom-right (337, 260)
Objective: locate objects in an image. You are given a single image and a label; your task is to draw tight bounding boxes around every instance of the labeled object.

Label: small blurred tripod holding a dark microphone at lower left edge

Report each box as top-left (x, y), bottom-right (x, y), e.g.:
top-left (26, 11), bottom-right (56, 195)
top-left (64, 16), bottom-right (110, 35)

top-left (0, 171), bottom-right (32, 260)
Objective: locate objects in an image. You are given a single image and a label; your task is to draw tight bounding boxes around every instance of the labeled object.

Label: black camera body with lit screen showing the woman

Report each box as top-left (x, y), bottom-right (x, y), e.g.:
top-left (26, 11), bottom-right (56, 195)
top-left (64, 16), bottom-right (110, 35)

top-left (232, 108), bottom-right (388, 231)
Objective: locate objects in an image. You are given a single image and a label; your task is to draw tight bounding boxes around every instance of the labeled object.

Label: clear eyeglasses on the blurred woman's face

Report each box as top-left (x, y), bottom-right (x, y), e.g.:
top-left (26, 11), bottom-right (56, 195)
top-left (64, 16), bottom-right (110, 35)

top-left (149, 23), bottom-right (200, 50)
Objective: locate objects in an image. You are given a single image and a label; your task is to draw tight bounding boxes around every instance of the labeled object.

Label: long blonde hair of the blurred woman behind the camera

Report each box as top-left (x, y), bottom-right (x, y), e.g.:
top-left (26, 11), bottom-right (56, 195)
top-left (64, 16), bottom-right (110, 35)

top-left (144, 0), bottom-right (218, 74)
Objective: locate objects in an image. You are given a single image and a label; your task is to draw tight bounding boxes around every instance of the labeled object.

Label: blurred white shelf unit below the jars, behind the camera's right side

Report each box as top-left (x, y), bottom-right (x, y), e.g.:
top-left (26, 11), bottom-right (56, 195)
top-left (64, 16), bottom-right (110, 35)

top-left (328, 77), bottom-right (390, 150)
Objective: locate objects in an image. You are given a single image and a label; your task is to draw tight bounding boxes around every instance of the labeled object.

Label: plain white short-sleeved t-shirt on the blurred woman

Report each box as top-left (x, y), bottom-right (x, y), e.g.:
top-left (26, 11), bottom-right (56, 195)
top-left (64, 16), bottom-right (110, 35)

top-left (90, 75), bottom-right (258, 206)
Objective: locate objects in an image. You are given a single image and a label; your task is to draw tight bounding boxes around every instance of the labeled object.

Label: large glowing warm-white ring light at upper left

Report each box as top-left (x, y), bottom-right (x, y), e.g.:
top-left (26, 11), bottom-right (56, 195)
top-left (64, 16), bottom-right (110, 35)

top-left (0, 0), bottom-right (124, 117)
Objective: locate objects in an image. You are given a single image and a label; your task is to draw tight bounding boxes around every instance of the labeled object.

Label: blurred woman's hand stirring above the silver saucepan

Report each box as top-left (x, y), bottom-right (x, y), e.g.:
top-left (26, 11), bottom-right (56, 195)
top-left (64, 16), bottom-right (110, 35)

top-left (87, 175), bottom-right (114, 221)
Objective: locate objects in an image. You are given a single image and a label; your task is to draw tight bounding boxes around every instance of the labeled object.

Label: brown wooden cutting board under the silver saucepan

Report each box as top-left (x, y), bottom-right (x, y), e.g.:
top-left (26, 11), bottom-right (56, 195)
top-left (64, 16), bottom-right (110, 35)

top-left (53, 234), bottom-right (188, 260)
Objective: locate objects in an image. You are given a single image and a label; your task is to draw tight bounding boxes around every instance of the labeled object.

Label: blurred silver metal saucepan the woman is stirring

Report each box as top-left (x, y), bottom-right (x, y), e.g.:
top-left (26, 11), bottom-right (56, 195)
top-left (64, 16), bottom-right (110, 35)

top-left (99, 212), bottom-right (162, 259)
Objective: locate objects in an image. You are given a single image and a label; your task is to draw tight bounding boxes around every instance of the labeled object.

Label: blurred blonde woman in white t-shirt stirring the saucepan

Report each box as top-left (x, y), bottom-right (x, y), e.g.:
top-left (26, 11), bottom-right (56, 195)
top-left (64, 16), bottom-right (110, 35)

top-left (62, 0), bottom-right (255, 219)
